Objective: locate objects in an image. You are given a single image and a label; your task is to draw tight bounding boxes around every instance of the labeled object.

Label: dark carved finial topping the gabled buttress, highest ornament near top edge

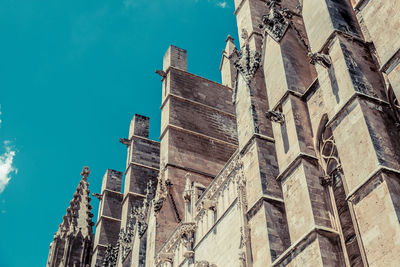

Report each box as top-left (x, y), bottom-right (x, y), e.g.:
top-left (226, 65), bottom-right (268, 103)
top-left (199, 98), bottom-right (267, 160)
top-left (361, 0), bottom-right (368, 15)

top-left (259, 5), bottom-right (290, 43)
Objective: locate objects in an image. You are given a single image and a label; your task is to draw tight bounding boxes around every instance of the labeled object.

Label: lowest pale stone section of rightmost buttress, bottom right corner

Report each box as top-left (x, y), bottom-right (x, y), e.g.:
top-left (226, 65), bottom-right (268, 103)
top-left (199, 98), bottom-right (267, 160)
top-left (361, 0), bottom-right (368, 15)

top-left (352, 173), bottom-right (400, 266)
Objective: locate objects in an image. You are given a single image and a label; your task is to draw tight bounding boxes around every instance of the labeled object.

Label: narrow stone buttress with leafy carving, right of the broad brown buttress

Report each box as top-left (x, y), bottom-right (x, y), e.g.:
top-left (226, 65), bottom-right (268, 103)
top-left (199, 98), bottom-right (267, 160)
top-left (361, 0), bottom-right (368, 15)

top-left (233, 0), bottom-right (289, 266)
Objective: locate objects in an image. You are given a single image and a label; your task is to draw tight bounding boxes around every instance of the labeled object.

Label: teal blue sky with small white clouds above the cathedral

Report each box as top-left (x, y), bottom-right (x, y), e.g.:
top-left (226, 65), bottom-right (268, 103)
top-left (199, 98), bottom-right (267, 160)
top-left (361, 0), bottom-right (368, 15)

top-left (0, 0), bottom-right (237, 267)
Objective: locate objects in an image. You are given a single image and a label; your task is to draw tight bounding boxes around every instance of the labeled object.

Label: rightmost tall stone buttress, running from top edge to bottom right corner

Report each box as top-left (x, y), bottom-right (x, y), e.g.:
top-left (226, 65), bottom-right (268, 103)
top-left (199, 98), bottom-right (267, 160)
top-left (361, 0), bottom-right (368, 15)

top-left (303, 0), bottom-right (400, 266)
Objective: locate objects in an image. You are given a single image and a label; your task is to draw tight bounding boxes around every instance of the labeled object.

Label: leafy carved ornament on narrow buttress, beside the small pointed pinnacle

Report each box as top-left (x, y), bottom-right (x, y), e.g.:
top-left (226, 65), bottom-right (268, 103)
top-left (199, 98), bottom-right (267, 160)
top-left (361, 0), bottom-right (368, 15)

top-left (234, 45), bottom-right (261, 84)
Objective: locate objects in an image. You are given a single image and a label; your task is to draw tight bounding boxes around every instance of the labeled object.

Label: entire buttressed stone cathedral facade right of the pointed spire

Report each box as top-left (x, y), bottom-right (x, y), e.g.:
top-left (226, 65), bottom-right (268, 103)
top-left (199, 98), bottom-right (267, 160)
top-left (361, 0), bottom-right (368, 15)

top-left (48, 0), bottom-right (400, 267)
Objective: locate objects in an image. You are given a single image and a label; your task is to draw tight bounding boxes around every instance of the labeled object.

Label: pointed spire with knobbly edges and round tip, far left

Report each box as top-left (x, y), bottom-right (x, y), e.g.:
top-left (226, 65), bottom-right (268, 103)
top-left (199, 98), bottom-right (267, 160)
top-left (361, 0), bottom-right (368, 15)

top-left (46, 167), bottom-right (94, 267)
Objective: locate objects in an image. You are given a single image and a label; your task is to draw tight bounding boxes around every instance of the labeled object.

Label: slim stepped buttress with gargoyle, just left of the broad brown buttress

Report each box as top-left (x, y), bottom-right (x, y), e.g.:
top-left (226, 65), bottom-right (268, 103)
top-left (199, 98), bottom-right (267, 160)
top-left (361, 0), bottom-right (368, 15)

top-left (117, 114), bottom-right (160, 267)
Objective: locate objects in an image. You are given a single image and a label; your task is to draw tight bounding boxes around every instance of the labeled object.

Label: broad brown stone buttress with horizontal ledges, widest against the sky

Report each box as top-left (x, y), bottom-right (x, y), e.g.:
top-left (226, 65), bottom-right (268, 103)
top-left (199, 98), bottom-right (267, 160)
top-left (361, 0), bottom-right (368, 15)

top-left (153, 46), bottom-right (237, 260)
